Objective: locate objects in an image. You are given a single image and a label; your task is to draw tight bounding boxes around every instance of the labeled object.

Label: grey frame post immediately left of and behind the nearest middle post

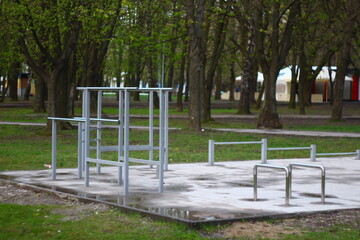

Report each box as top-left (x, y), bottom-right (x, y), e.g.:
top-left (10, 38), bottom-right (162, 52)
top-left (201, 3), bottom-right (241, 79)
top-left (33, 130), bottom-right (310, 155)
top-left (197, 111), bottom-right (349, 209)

top-left (118, 90), bottom-right (125, 185)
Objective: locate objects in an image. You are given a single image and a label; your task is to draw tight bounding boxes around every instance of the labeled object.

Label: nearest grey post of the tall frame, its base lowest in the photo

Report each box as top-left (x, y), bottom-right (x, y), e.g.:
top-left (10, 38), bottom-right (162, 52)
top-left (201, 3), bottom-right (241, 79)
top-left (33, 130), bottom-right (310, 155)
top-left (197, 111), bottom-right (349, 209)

top-left (124, 90), bottom-right (130, 195)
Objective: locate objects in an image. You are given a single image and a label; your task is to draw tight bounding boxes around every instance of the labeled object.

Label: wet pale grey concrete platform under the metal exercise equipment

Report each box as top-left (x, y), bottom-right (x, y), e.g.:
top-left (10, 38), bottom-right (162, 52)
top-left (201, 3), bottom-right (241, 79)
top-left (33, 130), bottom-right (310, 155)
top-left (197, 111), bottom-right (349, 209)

top-left (0, 157), bottom-right (360, 224)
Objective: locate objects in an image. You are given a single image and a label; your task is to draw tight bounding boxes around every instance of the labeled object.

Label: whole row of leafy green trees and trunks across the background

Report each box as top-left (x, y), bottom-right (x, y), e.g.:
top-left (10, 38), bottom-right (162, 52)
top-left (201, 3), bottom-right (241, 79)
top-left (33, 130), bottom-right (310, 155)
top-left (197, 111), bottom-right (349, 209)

top-left (0, 0), bottom-right (360, 130)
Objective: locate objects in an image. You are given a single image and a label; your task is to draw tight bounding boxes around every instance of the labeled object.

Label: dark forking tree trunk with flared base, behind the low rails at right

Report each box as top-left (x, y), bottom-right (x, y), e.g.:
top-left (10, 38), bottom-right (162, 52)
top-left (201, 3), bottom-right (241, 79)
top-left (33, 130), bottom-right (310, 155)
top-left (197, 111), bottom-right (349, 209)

top-left (254, 0), bottom-right (300, 128)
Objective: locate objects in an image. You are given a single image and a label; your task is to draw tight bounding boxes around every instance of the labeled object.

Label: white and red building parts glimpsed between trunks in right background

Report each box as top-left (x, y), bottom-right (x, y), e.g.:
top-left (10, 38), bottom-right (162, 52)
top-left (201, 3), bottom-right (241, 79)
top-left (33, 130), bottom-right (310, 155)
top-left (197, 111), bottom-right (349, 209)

top-left (221, 67), bottom-right (360, 102)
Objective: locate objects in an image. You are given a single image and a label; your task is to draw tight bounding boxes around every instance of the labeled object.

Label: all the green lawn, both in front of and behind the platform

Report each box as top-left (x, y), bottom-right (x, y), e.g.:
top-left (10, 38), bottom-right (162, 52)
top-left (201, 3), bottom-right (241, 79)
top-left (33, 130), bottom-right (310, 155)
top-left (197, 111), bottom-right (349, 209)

top-left (0, 103), bottom-right (360, 240)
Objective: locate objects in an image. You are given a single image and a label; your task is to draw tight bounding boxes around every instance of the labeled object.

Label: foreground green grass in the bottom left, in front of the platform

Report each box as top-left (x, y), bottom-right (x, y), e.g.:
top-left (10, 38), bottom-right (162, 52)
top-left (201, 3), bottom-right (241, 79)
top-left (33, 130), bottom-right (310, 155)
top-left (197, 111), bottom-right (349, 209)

top-left (0, 204), bottom-right (205, 240)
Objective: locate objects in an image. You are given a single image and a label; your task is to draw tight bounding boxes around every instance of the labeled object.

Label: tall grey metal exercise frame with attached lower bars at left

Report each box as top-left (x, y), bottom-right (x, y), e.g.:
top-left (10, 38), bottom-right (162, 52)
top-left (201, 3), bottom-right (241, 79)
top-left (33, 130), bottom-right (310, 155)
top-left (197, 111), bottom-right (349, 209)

top-left (49, 87), bottom-right (172, 195)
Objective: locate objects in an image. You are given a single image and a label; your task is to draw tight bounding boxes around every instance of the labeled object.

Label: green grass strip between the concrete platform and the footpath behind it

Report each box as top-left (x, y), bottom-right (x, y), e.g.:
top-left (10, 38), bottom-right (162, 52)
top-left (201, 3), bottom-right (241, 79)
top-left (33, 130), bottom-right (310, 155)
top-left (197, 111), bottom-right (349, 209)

top-left (0, 125), bottom-right (360, 171)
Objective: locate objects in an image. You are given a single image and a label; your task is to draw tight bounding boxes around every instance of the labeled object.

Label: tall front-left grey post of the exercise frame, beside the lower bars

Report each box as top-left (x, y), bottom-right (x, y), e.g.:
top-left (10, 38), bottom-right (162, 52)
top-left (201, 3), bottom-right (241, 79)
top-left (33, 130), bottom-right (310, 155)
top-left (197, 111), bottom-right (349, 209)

top-left (83, 89), bottom-right (90, 187)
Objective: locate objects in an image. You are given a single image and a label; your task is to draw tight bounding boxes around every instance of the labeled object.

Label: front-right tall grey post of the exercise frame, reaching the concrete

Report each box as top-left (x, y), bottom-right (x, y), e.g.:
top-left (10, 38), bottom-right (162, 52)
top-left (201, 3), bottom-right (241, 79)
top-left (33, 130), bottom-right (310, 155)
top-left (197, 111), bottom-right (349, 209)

top-left (158, 90), bottom-right (165, 192)
